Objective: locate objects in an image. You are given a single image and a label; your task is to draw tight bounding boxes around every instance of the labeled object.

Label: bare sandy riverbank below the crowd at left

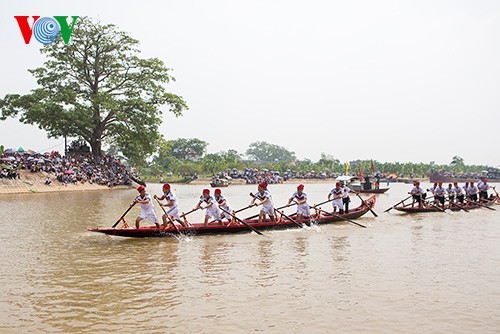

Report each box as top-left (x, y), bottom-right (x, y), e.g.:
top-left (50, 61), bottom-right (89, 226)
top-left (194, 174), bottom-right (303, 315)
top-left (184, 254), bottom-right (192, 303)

top-left (0, 170), bottom-right (130, 195)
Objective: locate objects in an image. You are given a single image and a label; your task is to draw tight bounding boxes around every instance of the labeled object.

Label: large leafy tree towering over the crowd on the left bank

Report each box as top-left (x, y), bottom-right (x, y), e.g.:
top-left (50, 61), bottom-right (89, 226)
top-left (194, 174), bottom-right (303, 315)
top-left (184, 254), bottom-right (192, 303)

top-left (0, 18), bottom-right (187, 161)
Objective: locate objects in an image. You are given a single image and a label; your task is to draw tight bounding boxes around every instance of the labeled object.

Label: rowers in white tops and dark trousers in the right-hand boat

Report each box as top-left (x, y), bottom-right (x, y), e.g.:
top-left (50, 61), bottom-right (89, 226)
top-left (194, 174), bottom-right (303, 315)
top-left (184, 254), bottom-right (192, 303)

top-left (408, 177), bottom-right (495, 208)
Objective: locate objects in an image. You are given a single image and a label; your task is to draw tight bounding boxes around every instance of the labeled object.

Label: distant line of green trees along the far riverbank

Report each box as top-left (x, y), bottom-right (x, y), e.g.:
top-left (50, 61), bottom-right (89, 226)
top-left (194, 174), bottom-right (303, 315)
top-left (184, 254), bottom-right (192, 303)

top-left (134, 138), bottom-right (498, 177)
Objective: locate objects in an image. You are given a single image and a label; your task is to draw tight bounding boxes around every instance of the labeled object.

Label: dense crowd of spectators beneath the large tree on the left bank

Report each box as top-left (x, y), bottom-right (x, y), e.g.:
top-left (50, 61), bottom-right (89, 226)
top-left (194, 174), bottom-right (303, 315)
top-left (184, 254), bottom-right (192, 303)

top-left (0, 150), bottom-right (140, 187)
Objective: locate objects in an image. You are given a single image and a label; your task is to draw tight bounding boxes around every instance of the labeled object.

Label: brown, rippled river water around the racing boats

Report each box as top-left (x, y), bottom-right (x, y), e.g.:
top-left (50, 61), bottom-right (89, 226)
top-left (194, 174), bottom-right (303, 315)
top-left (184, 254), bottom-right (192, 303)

top-left (0, 183), bottom-right (500, 333)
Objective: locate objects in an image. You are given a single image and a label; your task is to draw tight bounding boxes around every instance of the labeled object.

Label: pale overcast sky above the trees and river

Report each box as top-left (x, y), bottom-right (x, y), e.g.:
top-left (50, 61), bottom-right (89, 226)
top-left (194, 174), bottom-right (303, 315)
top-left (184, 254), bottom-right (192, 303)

top-left (0, 0), bottom-right (500, 166)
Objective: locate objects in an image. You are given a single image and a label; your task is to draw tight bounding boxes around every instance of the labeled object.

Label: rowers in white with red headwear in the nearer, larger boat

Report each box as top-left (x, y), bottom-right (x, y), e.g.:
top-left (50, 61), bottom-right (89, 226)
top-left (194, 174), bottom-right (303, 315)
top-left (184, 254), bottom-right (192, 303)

top-left (130, 182), bottom-right (356, 229)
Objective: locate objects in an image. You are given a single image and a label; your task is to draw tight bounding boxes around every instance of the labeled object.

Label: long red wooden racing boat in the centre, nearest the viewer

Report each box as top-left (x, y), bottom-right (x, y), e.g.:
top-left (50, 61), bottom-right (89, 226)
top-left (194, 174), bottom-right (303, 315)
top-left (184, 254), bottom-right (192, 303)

top-left (86, 195), bottom-right (376, 238)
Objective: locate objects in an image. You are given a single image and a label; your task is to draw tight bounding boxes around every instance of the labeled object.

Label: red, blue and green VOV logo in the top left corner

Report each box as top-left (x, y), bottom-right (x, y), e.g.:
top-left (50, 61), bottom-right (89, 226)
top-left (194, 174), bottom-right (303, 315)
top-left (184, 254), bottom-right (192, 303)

top-left (14, 16), bottom-right (79, 44)
